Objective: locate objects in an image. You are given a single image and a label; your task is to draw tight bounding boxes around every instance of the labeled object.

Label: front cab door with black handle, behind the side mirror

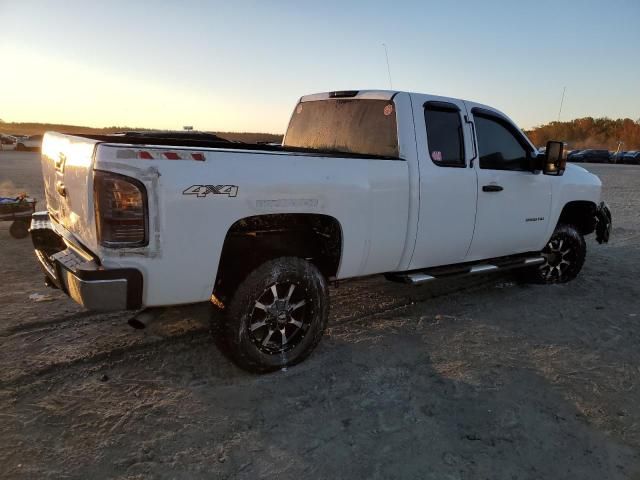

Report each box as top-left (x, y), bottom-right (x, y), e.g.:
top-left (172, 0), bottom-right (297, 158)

top-left (467, 105), bottom-right (551, 260)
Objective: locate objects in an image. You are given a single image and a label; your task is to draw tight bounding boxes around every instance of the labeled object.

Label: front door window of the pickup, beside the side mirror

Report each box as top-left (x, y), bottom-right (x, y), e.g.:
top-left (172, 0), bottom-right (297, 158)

top-left (474, 113), bottom-right (530, 172)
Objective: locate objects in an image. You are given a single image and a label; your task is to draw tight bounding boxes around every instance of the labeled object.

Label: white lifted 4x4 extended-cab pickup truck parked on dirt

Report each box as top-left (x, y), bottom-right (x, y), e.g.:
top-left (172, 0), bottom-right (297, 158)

top-left (31, 91), bottom-right (611, 371)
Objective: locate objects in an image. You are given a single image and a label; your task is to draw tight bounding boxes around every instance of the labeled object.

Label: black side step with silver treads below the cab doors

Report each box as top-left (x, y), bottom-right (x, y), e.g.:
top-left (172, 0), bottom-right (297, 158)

top-left (386, 255), bottom-right (545, 285)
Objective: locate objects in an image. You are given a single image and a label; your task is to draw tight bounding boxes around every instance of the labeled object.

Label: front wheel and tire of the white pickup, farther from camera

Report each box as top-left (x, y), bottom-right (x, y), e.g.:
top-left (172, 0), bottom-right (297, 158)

top-left (528, 224), bottom-right (587, 284)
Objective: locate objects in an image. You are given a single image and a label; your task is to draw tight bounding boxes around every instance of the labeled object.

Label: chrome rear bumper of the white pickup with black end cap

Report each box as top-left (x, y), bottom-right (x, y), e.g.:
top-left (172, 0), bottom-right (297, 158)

top-left (30, 212), bottom-right (142, 311)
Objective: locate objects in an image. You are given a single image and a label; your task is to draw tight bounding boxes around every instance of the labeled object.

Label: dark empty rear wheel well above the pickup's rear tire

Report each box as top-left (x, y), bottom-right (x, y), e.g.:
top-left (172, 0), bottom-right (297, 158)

top-left (214, 213), bottom-right (342, 299)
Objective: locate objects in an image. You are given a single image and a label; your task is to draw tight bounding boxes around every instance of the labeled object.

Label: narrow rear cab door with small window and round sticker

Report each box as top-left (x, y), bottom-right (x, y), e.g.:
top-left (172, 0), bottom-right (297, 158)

top-left (409, 95), bottom-right (477, 269)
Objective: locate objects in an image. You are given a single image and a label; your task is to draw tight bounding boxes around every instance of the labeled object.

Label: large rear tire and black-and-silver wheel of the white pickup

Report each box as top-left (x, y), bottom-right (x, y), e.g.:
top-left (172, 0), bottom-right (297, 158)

top-left (224, 257), bottom-right (329, 373)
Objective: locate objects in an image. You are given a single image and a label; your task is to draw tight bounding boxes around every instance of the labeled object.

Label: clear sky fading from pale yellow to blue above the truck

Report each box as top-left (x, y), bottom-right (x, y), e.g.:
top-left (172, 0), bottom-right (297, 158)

top-left (0, 0), bottom-right (640, 133)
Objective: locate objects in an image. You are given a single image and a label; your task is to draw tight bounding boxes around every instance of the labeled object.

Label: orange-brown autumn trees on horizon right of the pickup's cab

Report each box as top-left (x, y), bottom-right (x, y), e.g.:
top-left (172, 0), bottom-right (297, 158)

top-left (526, 117), bottom-right (640, 151)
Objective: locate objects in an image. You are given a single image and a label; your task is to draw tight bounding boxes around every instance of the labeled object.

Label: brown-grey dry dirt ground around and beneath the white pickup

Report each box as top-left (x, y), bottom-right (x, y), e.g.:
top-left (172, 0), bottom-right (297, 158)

top-left (0, 152), bottom-right (640, 479)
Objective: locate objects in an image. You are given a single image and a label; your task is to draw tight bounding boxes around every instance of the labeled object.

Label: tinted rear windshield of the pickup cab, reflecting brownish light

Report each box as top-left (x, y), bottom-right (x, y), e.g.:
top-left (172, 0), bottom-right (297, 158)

top-left (284, 99), bottom-right (398, 158)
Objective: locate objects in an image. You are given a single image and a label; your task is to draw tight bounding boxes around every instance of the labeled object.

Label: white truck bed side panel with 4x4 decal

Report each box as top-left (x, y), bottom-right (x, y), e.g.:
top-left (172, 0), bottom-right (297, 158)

top-left (95, 144), bottom-right (409, 306)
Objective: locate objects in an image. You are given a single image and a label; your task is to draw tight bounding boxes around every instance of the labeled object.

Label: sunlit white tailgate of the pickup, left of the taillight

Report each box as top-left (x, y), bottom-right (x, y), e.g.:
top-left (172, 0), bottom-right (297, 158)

top-left (42, 132), bottom-right (98, 250)
